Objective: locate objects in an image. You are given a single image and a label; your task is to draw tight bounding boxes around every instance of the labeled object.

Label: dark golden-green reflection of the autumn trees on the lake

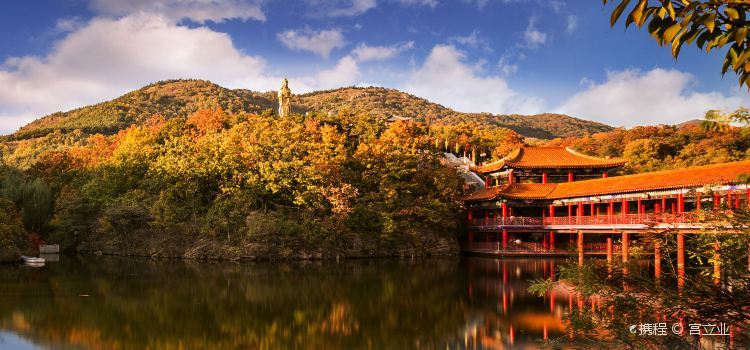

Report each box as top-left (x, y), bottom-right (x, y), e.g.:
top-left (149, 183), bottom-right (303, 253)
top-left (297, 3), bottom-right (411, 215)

top-left (0, 258), bottom-right (465, 349)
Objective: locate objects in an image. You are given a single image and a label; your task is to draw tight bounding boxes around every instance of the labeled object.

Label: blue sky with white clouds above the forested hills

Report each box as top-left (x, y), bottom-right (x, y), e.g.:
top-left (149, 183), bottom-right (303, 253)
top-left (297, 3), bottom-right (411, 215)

top-left (0, 0), bottom-right (750, 134)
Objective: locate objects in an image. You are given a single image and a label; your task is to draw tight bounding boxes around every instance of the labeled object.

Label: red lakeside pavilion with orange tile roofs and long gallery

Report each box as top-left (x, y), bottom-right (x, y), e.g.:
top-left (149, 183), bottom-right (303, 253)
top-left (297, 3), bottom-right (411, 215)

top-left (462, 147), bottom-right (750, 256)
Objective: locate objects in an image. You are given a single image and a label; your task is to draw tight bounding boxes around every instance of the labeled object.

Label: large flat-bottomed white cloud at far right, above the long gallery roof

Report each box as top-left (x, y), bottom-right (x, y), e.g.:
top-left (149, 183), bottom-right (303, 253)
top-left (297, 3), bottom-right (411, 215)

top-left (557, 68), bottom-right (750, 127)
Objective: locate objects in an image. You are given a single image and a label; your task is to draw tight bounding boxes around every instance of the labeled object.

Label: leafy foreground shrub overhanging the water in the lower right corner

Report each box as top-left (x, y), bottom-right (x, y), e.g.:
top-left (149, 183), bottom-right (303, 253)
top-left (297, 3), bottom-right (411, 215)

top-left (531, 209), bottom-right (750, 349)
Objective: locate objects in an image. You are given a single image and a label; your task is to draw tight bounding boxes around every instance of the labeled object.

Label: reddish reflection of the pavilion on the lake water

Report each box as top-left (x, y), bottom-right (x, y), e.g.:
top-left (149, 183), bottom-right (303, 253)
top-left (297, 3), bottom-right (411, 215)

top-left (458, 257), bottom-right (602, 349)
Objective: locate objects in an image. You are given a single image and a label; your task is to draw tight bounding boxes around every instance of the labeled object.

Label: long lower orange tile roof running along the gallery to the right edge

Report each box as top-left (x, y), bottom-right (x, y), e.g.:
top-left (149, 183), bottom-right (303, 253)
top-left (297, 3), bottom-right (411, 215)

top-left (464, 161), bottom-right (750, 201)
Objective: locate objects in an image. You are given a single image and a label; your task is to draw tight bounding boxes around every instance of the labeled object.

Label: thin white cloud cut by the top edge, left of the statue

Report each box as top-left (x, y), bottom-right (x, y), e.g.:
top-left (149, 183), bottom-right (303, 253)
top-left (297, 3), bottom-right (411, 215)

top-left (91, 0), bottom-right (266, 23)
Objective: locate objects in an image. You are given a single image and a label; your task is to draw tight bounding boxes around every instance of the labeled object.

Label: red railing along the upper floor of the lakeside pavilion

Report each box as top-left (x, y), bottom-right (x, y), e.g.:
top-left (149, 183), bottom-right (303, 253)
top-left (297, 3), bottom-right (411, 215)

top-left (469, 213), bottom-right (694, 227)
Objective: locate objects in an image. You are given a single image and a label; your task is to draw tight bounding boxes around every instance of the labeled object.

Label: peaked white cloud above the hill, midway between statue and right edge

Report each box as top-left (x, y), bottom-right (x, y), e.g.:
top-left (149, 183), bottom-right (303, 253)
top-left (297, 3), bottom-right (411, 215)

top-left (403, 45), bottom-right (543, 113)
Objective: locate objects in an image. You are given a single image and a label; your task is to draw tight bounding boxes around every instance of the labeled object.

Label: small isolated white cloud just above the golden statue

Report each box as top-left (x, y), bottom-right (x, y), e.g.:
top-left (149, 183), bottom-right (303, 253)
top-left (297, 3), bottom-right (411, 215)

top-left (276, 29), bottom-right (346, 58)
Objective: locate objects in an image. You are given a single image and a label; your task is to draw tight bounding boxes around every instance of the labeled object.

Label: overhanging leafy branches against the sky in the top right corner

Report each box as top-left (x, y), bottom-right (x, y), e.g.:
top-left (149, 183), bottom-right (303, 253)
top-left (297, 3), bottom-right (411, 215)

top-left (602, 0), bottom-right (750, 88)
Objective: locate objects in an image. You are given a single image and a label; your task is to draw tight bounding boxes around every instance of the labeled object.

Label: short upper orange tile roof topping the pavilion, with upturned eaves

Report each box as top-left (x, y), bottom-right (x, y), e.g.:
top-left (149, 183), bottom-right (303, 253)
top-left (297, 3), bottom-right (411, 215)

top-left (472, 147), bottom-right (626, 174)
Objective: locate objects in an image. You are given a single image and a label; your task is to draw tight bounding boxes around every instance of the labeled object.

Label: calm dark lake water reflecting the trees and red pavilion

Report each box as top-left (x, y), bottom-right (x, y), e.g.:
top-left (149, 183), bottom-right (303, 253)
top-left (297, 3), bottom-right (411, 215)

top-left (0, 257), bottom-right (578, 349)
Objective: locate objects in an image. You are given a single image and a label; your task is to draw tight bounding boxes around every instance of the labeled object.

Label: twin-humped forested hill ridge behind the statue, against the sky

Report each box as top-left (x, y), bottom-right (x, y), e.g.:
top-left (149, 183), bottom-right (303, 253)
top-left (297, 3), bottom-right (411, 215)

top-left (6, 80), bottom-right (612, 140)
